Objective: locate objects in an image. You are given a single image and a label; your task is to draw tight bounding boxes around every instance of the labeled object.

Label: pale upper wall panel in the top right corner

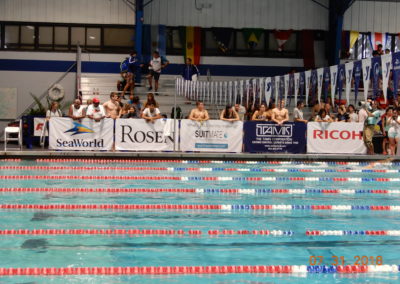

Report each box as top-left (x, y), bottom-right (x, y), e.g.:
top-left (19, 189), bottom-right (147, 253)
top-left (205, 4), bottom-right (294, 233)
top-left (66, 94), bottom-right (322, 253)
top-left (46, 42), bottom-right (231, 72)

top-left (343, 0), bottom-right (400, 33)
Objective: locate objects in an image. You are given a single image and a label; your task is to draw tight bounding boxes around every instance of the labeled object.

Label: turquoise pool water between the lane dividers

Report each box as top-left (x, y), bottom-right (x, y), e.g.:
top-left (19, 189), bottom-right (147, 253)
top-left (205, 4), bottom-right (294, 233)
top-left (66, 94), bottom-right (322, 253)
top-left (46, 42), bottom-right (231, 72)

top-left (0, 161), bottom-right (400, 283)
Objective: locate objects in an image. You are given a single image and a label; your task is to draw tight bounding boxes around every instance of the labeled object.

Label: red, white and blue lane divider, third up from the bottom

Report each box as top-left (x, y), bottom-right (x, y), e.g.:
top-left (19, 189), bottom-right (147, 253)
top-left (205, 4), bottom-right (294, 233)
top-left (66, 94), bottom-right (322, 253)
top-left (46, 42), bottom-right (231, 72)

top-left (0, 204), bottom-right (400, 211)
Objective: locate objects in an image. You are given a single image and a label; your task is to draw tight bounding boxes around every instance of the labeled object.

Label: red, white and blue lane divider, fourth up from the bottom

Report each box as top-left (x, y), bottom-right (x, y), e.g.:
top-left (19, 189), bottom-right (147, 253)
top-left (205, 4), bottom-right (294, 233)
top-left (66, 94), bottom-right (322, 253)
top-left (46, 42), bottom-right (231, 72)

top-left (0, 187), bottom-right (400, 195)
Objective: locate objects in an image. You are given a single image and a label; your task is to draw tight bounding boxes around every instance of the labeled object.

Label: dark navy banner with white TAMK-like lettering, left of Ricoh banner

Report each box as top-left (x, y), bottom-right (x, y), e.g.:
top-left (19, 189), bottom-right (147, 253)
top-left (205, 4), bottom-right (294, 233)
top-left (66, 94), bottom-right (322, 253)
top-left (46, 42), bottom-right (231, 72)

top-left (244, 121), bottom-right (307, 153)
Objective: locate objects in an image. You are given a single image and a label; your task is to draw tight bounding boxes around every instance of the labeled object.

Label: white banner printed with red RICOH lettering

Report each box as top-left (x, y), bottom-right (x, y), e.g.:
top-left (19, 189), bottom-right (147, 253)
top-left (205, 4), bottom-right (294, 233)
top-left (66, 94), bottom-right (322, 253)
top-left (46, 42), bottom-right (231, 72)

top-left (307, 122), bottom-right (367, 154)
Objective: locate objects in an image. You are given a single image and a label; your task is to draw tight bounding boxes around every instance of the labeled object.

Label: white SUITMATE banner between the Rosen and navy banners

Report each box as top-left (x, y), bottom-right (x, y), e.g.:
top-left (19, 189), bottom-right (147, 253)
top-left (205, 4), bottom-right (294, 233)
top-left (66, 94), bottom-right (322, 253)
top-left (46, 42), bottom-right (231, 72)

top-left (180, 119), bottom-right (243, 152)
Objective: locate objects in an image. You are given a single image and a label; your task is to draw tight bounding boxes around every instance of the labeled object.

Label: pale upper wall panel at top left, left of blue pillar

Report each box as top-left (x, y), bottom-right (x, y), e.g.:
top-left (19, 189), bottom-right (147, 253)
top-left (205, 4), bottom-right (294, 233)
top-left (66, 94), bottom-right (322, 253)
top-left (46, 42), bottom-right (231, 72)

top-left (0, 0), bottom-right (135, 25)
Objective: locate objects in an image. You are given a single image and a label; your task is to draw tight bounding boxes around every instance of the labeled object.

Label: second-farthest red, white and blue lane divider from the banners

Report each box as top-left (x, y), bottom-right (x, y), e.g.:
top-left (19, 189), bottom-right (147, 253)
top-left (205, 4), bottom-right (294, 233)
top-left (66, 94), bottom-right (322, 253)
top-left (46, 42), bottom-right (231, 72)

top-left (0, 166), bottom-right (400, 173)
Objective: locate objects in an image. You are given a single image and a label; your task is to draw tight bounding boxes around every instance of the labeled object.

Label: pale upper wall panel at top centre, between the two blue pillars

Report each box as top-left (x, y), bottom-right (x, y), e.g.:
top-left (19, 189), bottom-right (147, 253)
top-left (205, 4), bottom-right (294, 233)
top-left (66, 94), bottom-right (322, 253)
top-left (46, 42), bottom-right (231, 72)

top-left (144, 0), bottom-right (329, 30)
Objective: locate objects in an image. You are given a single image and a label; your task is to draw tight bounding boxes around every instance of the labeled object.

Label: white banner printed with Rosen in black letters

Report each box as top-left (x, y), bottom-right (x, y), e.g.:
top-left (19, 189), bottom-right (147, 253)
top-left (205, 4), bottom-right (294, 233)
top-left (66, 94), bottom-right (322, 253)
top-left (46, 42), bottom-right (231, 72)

top-left (115, 119), bottom-right (173, 151)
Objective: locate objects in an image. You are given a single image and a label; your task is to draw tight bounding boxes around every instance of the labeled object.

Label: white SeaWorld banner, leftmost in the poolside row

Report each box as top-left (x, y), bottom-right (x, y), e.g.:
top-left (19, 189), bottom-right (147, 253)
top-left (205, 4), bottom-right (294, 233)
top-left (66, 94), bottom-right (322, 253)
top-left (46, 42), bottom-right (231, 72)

top-left (49, 117), bottom-right (114, 150)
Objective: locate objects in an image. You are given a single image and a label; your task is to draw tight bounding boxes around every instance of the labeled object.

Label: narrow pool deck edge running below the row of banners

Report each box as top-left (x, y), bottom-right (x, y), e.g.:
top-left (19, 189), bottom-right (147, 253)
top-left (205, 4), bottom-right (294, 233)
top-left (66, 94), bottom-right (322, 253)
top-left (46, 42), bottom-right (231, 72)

top-left (0, 148), bottom-right (400, 161)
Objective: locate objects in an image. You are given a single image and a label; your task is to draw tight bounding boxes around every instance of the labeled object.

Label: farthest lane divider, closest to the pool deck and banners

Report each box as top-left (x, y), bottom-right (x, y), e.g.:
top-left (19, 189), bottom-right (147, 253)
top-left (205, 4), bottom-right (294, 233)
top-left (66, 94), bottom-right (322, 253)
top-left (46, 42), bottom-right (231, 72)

top-left (36, 158), bottom-right (400, 166)
